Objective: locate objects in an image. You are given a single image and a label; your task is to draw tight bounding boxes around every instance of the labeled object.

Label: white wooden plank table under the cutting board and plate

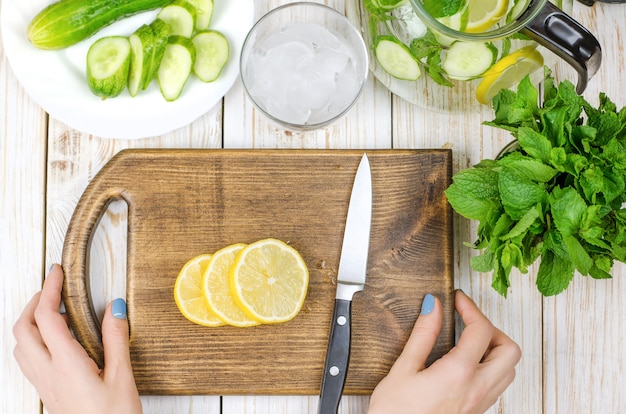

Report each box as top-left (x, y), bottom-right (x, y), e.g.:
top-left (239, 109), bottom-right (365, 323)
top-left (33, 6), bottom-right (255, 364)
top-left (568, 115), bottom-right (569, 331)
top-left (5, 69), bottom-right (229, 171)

top-left (0, 0), bottom-right (626, 414)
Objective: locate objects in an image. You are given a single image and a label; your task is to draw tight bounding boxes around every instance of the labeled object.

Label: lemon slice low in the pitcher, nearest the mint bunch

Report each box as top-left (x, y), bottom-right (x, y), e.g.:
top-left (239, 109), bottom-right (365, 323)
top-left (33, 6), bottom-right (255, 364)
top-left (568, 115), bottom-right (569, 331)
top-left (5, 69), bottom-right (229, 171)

top-left (476, 46), bottom-right (543, 104)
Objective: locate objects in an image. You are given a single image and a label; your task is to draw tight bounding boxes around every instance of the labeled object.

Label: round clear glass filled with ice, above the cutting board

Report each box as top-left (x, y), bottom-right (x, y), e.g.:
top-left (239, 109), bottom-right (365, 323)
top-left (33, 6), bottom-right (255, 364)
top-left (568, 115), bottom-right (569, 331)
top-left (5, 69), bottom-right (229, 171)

top-left (240, 2), bottom-right (369, 130)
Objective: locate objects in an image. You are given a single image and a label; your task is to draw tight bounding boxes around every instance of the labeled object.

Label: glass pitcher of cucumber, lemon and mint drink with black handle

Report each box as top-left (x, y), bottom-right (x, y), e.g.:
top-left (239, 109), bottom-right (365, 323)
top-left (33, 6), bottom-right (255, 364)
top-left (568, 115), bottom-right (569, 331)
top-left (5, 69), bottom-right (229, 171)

top-left (362, 0), bottom-right (600, 109)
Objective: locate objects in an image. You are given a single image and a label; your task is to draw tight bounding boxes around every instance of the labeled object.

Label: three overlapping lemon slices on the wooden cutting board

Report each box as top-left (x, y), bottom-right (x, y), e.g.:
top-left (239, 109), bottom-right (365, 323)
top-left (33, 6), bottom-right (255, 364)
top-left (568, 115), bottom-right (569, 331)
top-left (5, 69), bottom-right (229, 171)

top-left (174, 239), bottom-right (309, 327)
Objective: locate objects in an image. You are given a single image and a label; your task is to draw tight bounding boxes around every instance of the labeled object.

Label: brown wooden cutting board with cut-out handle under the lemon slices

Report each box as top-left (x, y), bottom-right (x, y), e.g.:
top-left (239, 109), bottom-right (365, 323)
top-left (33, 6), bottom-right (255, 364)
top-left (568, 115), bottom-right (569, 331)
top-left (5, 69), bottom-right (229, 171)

top-left (63, 149), bottom-right (454, 395)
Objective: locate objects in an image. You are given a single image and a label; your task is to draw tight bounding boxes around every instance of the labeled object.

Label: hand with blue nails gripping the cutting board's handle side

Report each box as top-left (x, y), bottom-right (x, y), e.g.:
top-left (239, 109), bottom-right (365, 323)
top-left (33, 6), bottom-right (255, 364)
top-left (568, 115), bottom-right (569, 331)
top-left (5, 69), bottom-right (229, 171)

top-left (13, 265), bottom-right (142, 414)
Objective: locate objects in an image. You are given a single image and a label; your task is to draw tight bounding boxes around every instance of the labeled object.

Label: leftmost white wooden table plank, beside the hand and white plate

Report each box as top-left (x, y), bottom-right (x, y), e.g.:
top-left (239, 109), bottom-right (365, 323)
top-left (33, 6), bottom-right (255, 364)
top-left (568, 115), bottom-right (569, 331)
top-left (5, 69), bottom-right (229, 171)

top-left (0, 34), bottom-right (47, 414)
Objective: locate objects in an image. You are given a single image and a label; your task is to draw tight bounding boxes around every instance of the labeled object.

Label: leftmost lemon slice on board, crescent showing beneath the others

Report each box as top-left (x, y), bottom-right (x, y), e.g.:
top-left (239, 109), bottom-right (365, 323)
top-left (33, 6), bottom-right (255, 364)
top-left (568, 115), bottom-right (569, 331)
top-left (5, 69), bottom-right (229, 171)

top-left (174, 254), bottom-right (224, 326)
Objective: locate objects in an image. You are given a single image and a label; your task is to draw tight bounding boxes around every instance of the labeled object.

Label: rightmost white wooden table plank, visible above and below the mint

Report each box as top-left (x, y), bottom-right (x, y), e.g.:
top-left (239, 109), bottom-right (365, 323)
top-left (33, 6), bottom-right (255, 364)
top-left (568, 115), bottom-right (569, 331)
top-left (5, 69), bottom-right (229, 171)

top-left (543, 2), bottom-right (626, 414)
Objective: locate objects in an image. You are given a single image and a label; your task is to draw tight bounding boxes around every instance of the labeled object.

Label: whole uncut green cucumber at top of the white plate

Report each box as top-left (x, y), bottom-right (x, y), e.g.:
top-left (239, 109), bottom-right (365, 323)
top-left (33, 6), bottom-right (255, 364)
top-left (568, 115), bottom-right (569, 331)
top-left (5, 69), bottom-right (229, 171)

top-left (27, 0), bottom-right (172, 50)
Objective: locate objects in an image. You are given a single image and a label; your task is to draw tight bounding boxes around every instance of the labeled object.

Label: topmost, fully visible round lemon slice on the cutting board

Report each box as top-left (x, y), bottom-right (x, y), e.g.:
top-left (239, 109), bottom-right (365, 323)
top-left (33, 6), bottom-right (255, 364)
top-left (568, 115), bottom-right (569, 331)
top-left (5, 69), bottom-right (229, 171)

top-left (230, 239), bottom-right (309, 323)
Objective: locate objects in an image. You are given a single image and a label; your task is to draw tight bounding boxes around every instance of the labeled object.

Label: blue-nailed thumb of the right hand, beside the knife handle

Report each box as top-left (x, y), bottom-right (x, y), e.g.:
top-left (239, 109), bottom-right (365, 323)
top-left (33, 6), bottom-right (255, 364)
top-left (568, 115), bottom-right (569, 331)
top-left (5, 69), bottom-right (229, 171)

top-left (392, 293), bottom-right (442, 374)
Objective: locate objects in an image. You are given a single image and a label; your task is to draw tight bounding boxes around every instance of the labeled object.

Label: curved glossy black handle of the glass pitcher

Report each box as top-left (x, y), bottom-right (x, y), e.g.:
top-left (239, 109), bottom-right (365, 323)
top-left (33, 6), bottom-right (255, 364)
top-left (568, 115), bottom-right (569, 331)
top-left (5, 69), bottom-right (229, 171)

top-left (521, 0), bottom-right (602, 94)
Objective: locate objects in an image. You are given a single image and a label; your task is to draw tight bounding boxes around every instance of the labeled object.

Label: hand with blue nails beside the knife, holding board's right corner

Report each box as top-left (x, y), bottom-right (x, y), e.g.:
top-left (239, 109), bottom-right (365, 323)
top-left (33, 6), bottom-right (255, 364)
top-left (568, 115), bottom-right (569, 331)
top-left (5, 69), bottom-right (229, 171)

top-left (368, 291), bottom-right (521, 414)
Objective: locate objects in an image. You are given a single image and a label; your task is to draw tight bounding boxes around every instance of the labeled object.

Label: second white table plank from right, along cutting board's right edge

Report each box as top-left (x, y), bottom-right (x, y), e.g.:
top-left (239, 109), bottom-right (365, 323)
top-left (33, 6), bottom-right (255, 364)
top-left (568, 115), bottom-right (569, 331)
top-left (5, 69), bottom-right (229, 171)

top-left (393, 94), bottom-right (543, 413)
